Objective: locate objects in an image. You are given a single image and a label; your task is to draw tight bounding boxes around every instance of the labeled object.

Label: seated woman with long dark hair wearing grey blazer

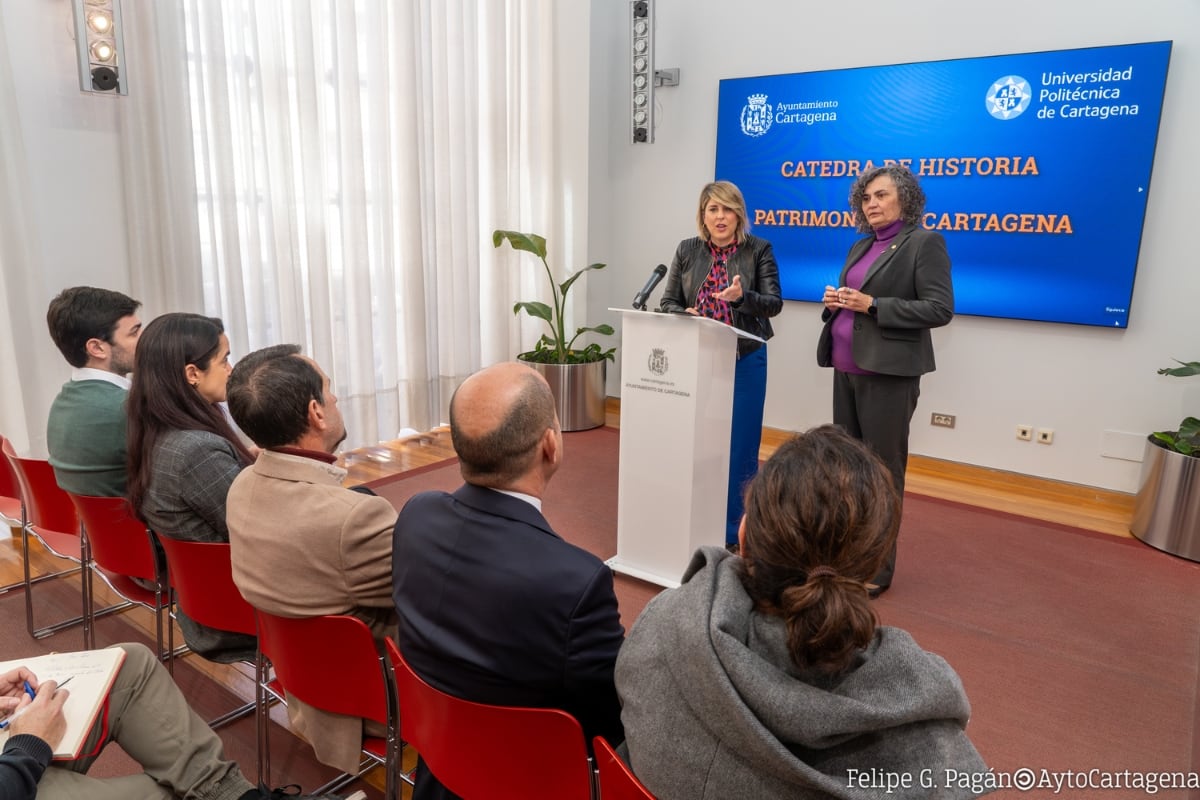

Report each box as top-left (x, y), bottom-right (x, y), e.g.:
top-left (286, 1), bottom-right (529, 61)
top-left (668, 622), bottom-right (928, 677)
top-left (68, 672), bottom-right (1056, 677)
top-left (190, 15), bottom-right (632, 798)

top-left (126, 313), bottom-right (256, 662)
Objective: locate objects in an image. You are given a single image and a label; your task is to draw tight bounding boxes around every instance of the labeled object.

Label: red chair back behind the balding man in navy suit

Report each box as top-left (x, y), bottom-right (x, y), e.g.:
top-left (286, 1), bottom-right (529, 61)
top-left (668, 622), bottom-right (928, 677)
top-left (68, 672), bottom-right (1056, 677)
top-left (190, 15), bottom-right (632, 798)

top-left (386, 638), bottom-right (594, 800)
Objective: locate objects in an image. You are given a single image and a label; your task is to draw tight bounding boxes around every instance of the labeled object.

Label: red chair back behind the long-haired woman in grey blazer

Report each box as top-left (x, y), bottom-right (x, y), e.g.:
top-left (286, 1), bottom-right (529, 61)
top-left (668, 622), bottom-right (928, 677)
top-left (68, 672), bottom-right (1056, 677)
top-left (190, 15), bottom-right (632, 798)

top-left (158, 536), bottom-right (257, 636)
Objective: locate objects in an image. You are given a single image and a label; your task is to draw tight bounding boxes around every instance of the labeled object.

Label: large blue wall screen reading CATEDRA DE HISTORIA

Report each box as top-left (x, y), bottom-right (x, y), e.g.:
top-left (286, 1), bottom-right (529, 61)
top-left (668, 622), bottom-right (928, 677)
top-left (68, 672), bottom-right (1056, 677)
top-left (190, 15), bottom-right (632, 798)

top-left (715, 42), bottom-right (1171, 327)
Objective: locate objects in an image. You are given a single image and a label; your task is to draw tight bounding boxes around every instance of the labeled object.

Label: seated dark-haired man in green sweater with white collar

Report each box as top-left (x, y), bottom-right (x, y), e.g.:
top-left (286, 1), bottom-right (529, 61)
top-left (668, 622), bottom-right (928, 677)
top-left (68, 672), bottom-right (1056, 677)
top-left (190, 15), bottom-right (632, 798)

top-left (46, 287), bottom-right (142, 497)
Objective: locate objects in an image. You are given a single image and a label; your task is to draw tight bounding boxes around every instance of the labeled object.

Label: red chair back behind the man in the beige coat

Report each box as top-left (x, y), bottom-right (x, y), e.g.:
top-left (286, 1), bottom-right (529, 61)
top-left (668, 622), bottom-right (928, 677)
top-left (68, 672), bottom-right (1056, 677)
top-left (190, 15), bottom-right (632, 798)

top-left (254, 608), bottom-right (388, 726)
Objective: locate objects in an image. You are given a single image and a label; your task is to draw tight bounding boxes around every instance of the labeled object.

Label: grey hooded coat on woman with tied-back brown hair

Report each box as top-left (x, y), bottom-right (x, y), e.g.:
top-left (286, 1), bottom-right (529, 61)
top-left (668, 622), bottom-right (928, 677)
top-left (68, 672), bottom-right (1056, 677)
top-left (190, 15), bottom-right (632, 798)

top-left (616, 547), bottom-right (988, 800)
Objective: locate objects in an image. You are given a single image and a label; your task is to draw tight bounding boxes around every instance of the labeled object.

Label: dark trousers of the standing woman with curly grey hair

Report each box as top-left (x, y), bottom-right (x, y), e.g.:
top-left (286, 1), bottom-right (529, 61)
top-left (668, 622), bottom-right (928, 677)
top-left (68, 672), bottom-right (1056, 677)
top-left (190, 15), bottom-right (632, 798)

top-left (833, 369), bottom-right (920, 587)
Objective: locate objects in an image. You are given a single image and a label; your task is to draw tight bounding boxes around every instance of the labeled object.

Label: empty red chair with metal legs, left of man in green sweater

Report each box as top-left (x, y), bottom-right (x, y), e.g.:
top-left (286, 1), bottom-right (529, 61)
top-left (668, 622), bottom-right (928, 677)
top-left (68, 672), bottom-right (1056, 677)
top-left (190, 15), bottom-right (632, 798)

top-left (0, 439), bottom-right (93, 649)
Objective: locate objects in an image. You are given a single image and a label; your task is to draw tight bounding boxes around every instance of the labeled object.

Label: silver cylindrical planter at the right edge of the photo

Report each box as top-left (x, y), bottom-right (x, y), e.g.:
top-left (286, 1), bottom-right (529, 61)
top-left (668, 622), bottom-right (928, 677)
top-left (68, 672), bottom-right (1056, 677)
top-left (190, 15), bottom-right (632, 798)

top-left (1129, 438), bottom-right (1200, 561)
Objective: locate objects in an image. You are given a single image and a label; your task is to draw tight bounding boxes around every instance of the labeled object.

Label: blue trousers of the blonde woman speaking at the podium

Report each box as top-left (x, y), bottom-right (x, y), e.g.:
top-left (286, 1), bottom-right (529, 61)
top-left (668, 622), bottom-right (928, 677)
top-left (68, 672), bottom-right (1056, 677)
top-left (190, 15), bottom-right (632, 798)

top-left (725, 345), bottom-right (767, 545)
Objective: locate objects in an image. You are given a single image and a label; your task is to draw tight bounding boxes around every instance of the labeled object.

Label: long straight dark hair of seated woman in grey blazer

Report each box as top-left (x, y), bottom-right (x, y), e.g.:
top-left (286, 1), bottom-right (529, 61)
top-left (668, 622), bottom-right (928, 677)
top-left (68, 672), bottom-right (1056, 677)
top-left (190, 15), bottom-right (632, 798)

top-left (125, 313), bottom-right (254, 517)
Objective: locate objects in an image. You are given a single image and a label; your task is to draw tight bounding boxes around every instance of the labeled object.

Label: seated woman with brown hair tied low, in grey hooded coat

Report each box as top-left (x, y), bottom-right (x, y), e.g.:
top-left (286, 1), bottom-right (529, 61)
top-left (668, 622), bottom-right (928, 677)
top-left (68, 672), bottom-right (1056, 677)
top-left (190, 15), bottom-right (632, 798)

top-left (617, 426), bottom-right (988, 800)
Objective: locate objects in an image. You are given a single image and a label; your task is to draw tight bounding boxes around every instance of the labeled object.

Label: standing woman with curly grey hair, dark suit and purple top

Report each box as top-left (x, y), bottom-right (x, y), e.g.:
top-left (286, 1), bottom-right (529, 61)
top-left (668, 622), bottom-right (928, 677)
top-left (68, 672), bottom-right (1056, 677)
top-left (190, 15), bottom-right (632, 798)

top-left (817, 164), bottom-right (954, 596)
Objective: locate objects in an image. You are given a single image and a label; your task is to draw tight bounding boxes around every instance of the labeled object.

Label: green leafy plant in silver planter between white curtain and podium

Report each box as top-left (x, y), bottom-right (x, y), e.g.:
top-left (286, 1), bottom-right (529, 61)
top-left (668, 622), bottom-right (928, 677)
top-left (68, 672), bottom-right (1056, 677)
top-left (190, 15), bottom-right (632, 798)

top-left (492, 230), bottom-right (617, 363)
